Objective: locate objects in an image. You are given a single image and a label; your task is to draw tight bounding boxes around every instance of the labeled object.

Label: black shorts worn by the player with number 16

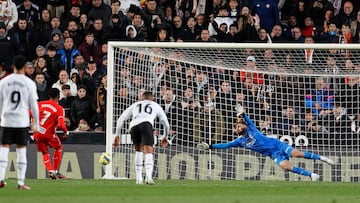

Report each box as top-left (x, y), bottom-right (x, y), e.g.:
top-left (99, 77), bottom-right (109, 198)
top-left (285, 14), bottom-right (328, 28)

top-left (130, 122), bottom-right (154, 146)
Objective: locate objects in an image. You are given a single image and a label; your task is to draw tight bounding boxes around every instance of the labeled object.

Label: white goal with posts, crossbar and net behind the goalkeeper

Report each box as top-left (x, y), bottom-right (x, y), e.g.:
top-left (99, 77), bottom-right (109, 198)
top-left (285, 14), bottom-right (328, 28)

top-left (104, 42), bottom-right (360, 182)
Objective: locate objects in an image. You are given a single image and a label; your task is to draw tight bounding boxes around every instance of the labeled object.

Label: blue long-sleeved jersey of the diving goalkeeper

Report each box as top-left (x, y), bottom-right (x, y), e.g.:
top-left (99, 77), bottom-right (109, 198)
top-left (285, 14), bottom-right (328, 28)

top-left (211, 115), bottom-right (288, 158)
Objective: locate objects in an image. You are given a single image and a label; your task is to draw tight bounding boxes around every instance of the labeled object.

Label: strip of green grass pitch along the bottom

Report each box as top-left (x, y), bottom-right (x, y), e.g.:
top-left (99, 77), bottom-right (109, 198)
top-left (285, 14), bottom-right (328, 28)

top-left (0, 179), bottom-right (360, 203)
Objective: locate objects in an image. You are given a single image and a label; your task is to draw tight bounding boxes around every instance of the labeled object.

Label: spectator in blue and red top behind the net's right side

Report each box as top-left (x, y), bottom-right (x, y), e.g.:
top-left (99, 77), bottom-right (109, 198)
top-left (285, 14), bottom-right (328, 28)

top-left (305, 78), bottom-right (334, 115)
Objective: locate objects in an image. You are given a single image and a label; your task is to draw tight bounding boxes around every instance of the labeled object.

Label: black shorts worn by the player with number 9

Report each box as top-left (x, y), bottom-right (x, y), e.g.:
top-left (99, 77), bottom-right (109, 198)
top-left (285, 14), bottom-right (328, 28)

top-left (0, 127), bottom-right (30, 145)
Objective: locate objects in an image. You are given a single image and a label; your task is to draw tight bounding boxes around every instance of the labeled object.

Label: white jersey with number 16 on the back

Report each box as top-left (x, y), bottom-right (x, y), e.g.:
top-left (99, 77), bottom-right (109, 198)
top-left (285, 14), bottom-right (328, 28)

top-left (116, 100), bottom-right (170, 135)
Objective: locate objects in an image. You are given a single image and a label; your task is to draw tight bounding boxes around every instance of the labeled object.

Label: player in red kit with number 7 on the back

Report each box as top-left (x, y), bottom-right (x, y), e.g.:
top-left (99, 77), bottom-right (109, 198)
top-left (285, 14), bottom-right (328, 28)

top-left (34, 88), bottom-right (68, 179)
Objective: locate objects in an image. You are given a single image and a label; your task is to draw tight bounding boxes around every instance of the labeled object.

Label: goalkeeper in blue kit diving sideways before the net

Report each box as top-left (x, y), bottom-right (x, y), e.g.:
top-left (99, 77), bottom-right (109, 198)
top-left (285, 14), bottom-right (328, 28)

top-left (198, 105), bottom-right (334, 181)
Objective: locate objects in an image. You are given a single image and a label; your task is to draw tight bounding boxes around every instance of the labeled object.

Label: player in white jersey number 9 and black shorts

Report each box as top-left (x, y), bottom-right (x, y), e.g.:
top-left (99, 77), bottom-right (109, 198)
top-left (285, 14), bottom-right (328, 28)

top-left (0, 55), bottom-right (39, 190)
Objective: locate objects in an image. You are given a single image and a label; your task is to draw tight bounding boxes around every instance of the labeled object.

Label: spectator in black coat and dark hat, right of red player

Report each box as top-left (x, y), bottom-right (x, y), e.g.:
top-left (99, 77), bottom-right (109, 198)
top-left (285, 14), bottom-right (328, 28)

top-left (70, 85), bottom-right (95, 129)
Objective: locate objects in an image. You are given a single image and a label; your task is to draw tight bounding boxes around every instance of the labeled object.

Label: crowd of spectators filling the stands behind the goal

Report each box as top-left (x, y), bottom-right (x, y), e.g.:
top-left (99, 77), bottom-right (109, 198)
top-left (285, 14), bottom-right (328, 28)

top-left (0, 0), bottom-right (360, 146)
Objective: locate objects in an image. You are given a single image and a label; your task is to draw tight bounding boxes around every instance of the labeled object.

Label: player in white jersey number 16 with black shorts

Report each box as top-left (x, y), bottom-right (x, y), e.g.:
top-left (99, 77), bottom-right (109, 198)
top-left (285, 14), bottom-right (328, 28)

top-left (115, 92), bottom-right (170, 185)
